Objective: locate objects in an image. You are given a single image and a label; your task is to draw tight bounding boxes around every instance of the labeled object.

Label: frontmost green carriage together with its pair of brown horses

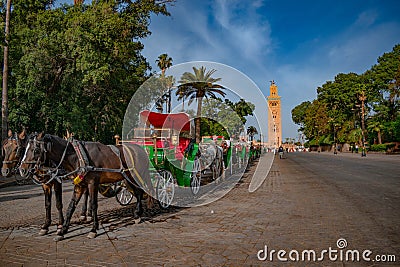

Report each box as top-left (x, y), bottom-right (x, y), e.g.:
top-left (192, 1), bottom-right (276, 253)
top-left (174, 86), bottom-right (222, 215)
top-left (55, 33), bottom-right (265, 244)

top-left (3, 110), bottom-right (233, 240)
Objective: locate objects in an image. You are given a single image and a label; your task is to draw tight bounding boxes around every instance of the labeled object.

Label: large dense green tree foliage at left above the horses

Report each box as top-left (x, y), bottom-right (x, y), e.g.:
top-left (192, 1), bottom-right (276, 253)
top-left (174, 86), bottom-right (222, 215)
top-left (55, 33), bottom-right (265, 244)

top-left (1, 0), bottom-right (171, 143)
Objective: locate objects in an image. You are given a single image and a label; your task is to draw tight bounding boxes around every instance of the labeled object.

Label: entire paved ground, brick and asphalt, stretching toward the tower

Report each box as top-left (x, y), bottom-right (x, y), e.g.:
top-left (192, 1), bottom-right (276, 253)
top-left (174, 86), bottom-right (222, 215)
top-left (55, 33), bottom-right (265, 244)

top-left (0, 153), bottom-right (400, 266)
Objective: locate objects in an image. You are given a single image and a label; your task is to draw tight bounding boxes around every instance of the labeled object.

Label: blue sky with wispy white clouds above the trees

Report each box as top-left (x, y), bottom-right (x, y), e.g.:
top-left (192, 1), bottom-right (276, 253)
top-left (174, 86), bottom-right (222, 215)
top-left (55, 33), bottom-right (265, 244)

top-left (60, 0), bottom-right (400, 142)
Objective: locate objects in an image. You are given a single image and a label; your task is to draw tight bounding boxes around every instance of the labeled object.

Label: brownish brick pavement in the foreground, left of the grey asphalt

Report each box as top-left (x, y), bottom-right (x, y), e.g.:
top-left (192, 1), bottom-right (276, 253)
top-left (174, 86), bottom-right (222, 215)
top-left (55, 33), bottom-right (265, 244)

top-left (0, 155), bottom-right (400, 266)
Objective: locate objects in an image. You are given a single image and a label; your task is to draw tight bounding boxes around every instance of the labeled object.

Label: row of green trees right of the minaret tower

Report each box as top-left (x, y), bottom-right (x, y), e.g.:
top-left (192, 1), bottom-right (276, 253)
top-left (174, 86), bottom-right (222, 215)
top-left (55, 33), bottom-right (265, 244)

top-left (292, 45), bottom-right (400, 147)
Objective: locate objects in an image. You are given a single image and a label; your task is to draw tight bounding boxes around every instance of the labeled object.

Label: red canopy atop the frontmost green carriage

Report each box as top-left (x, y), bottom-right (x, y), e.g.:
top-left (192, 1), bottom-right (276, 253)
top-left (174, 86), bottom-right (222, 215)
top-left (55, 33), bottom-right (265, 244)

top-left (140, 110), bottom-right (192, 132)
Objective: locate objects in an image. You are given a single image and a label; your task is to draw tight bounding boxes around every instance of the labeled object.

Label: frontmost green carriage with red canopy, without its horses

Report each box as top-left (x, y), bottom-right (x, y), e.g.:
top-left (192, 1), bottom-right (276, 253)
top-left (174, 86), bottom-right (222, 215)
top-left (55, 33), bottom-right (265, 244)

top-left (116, 110), bottom-right (202, 208)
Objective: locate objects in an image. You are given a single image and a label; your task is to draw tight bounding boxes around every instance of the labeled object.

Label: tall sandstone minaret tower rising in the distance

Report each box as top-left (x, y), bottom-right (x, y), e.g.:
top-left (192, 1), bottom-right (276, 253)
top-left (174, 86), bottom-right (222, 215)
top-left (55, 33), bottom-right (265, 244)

top-left (267, 81), bottom-right (282, 148)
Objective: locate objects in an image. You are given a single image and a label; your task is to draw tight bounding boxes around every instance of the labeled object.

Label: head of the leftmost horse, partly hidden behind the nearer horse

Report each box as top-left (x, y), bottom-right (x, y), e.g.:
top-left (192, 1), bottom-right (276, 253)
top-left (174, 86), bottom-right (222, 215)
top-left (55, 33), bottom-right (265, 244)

top-left (1, 130), bottom-right (26, 177)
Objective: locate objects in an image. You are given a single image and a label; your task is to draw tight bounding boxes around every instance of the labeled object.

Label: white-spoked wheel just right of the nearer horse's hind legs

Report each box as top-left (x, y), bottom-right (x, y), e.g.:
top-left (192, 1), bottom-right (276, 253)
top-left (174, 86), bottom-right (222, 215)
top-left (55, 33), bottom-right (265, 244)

top-left (156, 170), bottom-right (175, 209)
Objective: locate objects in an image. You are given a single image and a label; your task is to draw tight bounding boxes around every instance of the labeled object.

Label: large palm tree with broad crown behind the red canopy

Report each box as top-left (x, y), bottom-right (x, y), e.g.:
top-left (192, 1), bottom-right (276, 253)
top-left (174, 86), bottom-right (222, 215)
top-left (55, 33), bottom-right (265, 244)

top-left (176, 66), bottom-right (226, 143)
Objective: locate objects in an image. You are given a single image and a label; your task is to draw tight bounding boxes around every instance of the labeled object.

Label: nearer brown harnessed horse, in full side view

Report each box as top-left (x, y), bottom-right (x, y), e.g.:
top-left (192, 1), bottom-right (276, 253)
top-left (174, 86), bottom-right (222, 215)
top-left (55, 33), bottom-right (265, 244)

top-left (20, 133), bottom-right (151, 240)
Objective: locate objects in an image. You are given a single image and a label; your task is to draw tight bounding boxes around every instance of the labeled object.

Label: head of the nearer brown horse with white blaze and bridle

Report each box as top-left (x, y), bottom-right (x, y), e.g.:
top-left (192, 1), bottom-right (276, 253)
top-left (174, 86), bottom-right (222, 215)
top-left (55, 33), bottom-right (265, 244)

top-left (19, 133), bottom-right (51, 177)
